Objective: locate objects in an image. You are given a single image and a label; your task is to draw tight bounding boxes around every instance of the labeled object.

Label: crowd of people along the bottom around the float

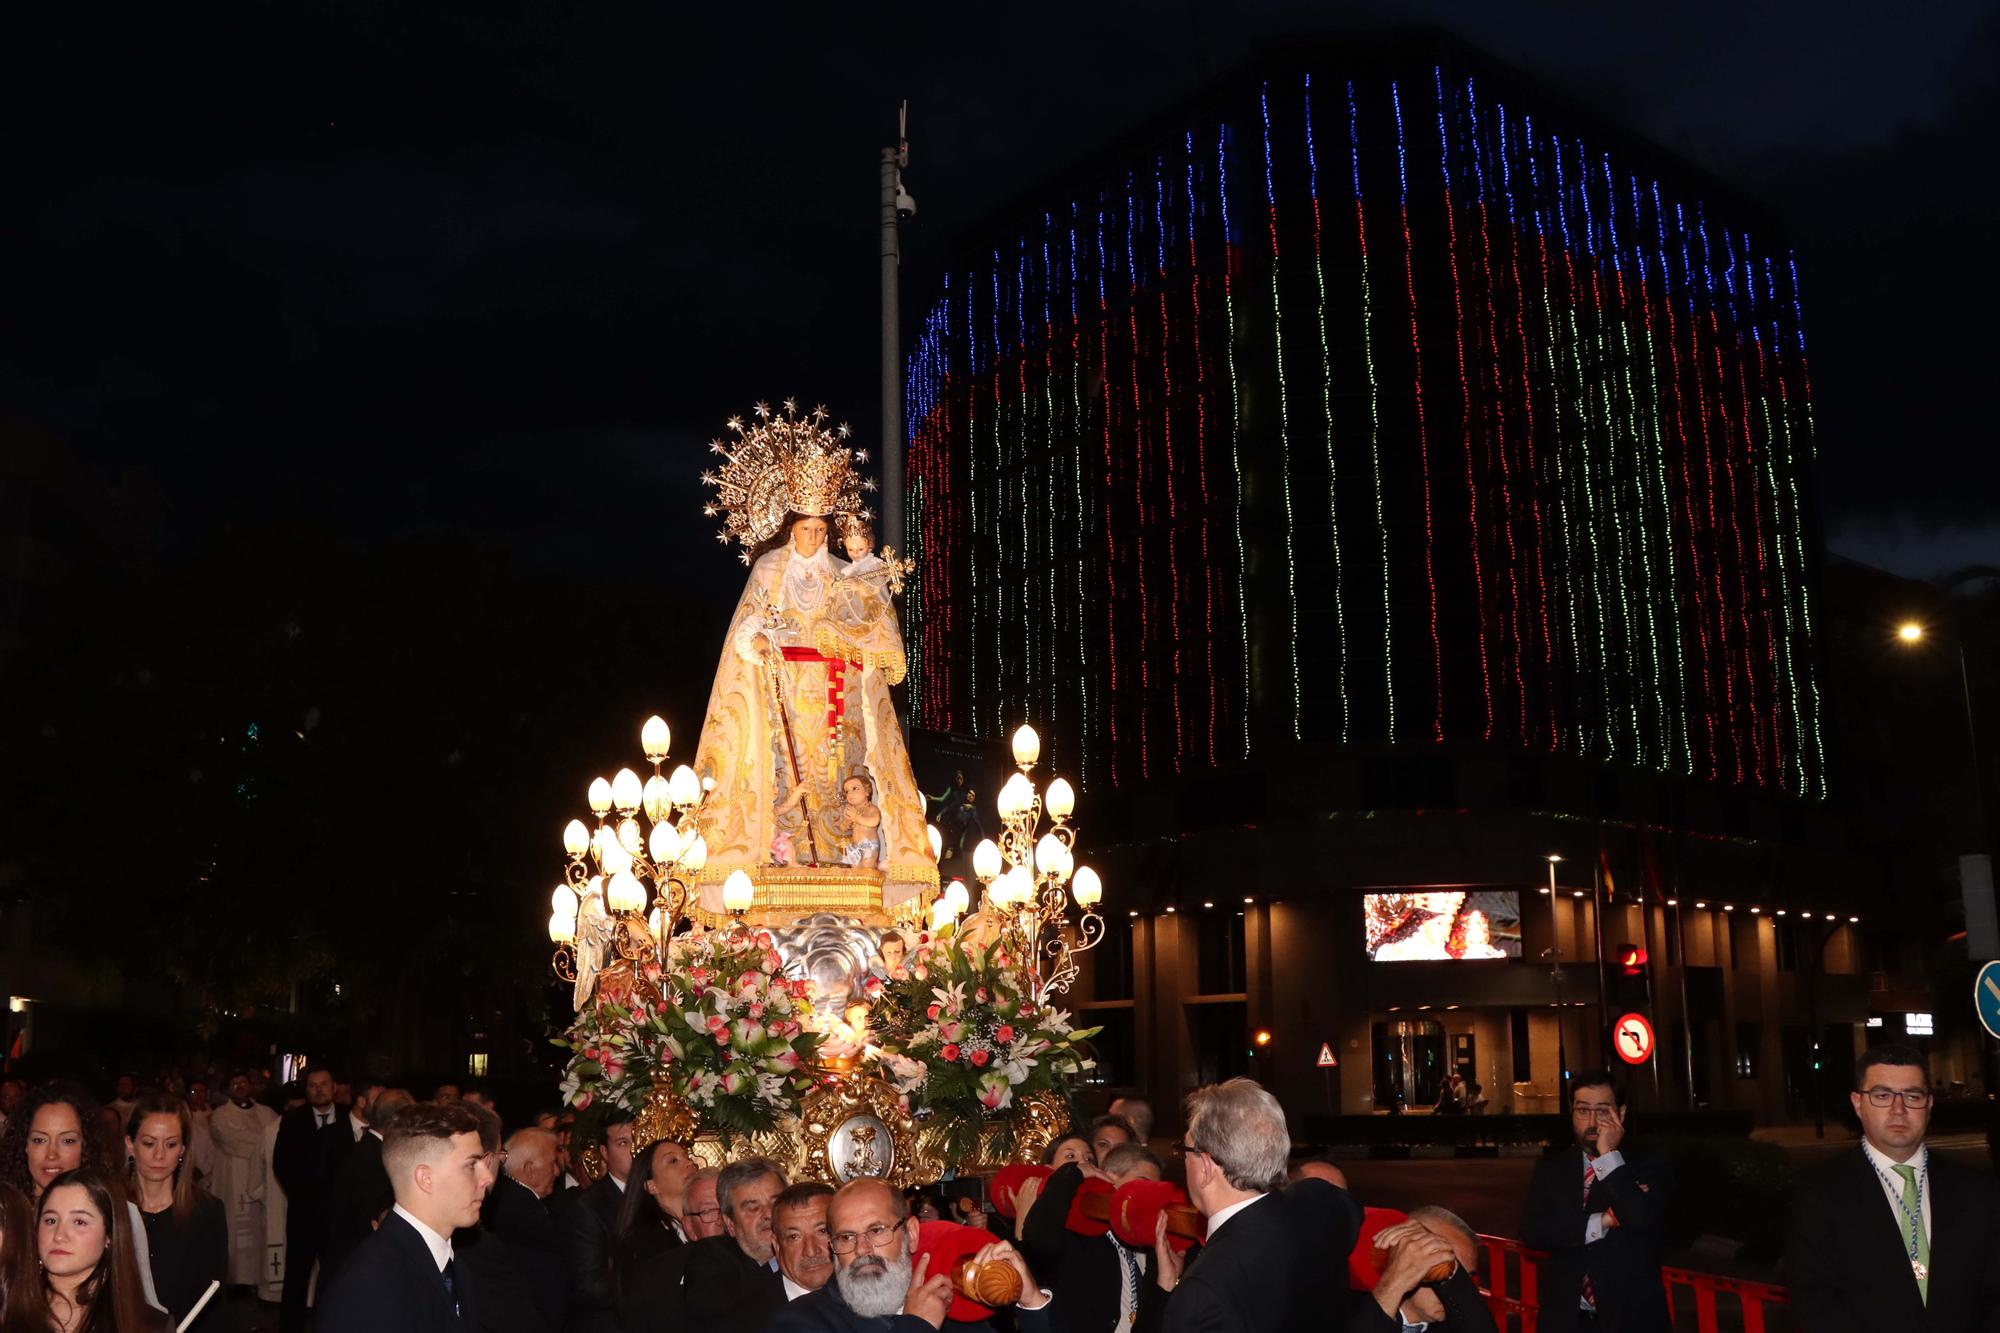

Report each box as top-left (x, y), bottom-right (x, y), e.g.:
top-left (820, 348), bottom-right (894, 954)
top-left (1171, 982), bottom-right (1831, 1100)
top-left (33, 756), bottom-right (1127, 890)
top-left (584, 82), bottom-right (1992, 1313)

top-left (0, 1047), bottom-right (2000, 1333)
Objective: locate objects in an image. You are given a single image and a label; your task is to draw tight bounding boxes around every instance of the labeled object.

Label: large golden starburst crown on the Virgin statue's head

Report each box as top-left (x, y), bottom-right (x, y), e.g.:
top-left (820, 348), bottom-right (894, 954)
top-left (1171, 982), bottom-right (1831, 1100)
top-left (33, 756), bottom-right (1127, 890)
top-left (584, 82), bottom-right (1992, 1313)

top-left (702, 398), bottom-right (876, 564)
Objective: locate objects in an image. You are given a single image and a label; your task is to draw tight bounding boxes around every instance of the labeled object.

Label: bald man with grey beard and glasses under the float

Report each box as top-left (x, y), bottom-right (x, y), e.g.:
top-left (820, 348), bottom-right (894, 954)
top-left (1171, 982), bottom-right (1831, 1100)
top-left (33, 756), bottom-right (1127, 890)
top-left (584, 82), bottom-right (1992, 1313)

top-left (764, 1177), bottom-right (1054, 1333)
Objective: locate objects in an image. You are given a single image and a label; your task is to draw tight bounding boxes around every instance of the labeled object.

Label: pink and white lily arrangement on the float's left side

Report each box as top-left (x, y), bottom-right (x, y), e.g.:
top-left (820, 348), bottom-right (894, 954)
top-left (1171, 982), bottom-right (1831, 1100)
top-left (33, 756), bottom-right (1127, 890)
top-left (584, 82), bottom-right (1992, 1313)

top-left (558, 927), bottom-right (822, 1135)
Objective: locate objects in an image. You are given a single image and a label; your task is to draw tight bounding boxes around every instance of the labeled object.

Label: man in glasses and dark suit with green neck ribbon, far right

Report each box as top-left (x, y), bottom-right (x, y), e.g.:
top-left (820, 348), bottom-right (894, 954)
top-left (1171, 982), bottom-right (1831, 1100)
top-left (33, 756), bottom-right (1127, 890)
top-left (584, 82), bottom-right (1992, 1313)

top-left (1786, 1043), bottom-right (2000, 1333)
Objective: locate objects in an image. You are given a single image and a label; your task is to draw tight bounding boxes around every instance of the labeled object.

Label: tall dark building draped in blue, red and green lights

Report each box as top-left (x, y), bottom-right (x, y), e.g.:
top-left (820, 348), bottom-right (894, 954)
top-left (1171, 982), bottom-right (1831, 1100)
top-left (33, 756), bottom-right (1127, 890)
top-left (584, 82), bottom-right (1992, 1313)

top-left (906, 40), bottom-right (1968, 1119)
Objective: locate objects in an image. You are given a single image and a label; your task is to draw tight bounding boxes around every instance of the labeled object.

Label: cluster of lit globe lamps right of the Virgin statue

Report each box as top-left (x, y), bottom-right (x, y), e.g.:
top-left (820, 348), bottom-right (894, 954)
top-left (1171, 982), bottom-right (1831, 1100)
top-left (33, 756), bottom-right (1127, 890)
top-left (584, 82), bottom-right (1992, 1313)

top-left (960, 725), bottom-right (1104, 999)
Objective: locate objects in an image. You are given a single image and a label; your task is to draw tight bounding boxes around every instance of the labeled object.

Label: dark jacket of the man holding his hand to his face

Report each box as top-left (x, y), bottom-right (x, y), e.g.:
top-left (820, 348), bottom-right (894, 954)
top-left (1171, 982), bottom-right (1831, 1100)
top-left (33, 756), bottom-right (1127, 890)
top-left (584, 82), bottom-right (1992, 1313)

top-left (1520, 1147), bottom-right (1672, 1333)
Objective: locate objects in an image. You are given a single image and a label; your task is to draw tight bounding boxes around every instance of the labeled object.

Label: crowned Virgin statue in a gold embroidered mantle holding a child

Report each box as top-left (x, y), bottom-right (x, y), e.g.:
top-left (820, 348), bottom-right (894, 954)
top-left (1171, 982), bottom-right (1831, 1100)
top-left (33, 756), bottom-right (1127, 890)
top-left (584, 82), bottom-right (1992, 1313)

top-left (694, 402), bottom-right (938, 913)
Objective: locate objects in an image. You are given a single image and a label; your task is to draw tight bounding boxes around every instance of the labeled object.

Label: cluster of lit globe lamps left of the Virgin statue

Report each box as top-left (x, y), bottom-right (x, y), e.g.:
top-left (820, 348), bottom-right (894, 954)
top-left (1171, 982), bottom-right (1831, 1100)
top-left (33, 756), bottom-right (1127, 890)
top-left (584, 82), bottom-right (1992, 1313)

top-left (548, 717), bottom-right (714, 983)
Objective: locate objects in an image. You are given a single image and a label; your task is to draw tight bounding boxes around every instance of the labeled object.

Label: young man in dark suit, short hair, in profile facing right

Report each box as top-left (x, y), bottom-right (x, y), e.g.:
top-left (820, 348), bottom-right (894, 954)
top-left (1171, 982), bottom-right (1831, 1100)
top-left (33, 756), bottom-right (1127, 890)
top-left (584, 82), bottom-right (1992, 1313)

top-left (318, 1103), bottom-right (488, 1333)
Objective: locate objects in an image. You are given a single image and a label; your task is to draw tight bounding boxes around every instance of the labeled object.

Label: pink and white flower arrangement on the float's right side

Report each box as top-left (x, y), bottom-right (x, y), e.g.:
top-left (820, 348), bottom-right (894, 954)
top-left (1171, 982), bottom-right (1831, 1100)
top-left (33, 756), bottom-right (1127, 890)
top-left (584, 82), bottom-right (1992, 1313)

top-left (872, 927), bottom-right (1102, 1157)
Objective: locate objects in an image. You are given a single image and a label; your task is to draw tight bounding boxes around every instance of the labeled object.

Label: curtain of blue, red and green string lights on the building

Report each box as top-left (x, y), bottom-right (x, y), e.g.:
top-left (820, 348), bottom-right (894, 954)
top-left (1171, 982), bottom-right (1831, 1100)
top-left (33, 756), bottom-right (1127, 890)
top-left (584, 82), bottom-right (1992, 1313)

top-left (906, 62), bottom-right (1826, 801)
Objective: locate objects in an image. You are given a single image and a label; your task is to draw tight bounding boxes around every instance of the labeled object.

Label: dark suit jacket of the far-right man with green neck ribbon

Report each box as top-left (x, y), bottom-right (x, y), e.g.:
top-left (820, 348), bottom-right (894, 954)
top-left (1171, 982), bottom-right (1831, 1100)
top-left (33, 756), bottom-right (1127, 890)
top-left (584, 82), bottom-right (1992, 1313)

top-left (1786, 1147), bottom-right (2000, 1333)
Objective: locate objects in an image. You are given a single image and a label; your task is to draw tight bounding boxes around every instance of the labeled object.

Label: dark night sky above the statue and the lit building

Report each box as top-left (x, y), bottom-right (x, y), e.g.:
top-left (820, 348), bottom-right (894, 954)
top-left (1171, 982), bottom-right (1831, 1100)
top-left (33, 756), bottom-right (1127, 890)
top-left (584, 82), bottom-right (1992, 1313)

top-left (0, 0), bottom-right (2000, 596)
